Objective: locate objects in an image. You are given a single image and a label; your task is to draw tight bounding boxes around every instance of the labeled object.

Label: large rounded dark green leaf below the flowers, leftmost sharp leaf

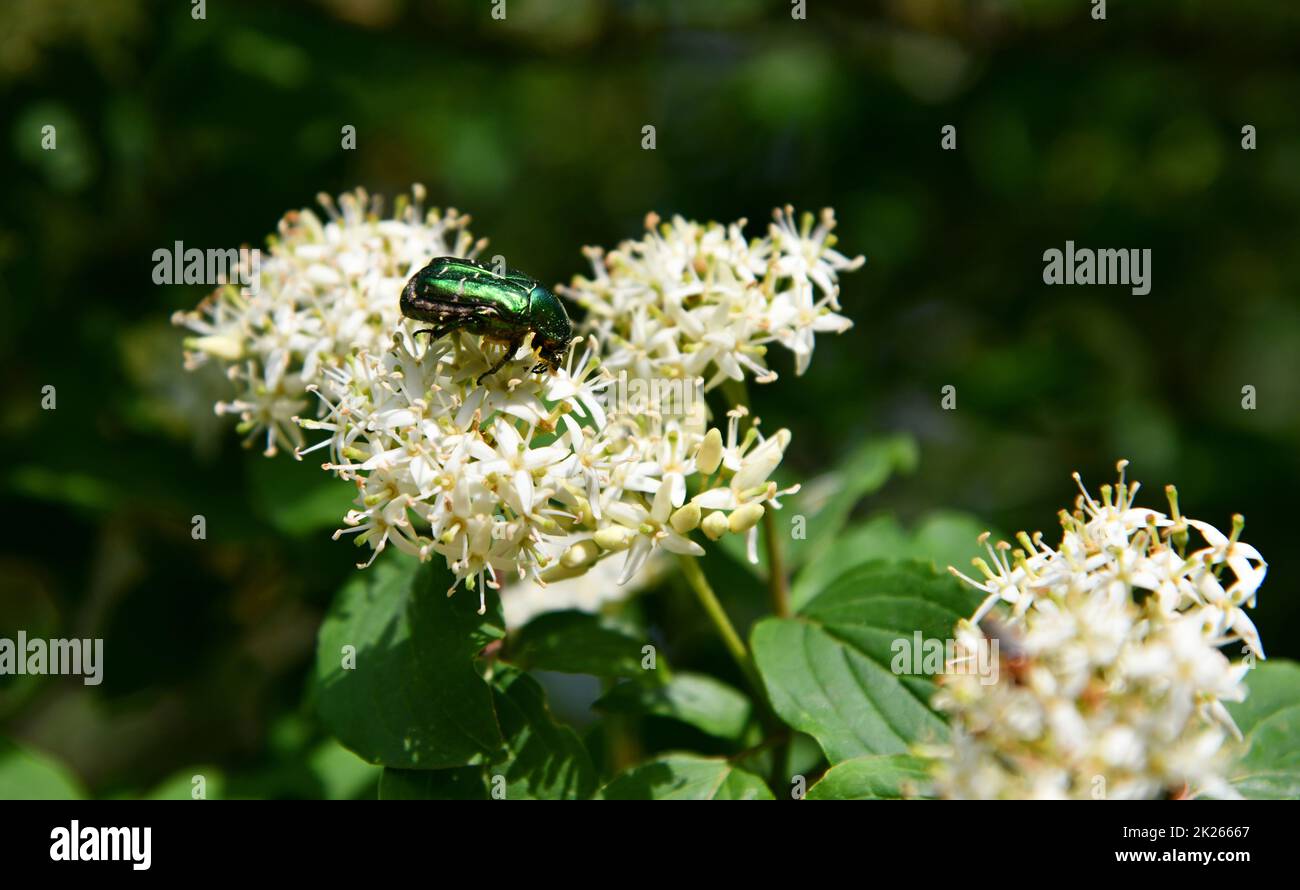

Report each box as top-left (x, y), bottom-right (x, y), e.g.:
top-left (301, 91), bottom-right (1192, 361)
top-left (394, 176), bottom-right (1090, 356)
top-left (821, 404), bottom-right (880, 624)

top-left (316, 552), bottom-right (503, 769)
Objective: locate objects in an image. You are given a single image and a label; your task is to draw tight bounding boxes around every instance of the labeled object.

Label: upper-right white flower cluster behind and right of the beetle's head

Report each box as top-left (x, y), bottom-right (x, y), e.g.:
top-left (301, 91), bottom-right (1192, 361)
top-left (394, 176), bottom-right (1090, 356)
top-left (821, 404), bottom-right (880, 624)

top-left (562, 207), bottom-right (865, 390)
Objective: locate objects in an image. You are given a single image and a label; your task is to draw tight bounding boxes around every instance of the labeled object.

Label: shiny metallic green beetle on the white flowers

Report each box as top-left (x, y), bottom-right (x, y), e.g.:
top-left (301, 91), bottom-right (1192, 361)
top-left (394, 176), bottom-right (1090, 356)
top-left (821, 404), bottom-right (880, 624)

top-left (402, 256), bottom-right (573, 383)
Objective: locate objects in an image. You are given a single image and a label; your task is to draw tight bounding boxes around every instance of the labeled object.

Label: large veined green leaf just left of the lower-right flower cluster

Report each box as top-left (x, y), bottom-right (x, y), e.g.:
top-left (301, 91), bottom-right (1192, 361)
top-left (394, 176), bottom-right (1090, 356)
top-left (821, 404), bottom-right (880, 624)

top-left (751, 561), bottom-right (979, 764)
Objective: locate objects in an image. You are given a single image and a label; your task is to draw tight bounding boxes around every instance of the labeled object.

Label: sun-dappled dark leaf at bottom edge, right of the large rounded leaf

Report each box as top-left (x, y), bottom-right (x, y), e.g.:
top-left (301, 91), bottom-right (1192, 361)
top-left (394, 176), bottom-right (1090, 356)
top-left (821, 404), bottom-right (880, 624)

top-left (489, 669), bottom-right (595, 800)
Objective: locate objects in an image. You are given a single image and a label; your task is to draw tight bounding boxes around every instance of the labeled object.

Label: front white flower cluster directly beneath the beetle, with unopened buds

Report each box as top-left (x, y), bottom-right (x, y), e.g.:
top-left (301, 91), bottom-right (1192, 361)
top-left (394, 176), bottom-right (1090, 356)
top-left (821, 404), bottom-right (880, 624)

top-left (300, 311), bottom-right (789, 610)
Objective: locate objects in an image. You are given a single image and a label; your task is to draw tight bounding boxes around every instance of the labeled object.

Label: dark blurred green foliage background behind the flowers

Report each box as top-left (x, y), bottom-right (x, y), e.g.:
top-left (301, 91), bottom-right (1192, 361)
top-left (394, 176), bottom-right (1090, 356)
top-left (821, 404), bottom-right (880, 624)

top-left (0, 0), bottom-right (1300, 796)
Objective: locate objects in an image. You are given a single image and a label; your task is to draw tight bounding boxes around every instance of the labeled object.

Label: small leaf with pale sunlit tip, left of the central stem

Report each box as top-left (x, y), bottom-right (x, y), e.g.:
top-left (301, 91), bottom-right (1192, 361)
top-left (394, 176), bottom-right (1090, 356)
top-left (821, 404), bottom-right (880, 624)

top-left (592, 672), bottom-right (753, 739)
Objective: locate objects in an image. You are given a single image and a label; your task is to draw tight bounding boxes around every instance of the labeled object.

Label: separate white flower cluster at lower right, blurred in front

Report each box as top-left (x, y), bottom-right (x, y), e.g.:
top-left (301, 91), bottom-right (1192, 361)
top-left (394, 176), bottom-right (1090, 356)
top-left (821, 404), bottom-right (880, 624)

top-left (935, 461), bottom-right (1268, 799)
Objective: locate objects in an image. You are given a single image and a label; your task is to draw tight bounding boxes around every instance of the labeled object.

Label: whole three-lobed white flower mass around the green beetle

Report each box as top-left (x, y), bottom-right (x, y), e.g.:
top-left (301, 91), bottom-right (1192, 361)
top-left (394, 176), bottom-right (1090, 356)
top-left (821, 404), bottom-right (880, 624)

top-left (176, 187), bottom-right (862, 610)
